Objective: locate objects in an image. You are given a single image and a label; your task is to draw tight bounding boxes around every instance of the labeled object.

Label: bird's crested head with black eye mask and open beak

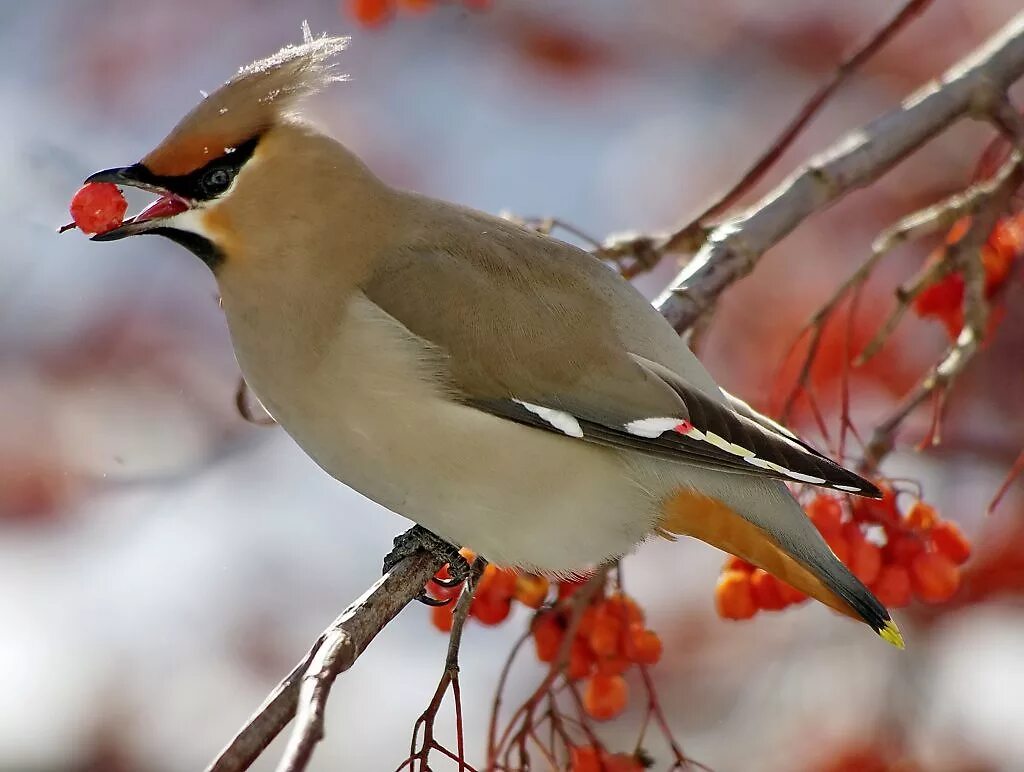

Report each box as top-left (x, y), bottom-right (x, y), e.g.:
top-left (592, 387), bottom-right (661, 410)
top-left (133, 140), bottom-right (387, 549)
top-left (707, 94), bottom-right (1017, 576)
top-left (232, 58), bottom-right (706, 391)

top-left (86, 28), bottom-right (360, 272)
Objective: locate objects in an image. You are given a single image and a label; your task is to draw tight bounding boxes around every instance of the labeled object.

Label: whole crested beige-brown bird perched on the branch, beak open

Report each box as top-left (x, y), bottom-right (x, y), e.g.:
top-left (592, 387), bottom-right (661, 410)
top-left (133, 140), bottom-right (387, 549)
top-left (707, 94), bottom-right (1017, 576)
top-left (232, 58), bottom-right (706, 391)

top-left (86, 27), bottom-right (903, 648)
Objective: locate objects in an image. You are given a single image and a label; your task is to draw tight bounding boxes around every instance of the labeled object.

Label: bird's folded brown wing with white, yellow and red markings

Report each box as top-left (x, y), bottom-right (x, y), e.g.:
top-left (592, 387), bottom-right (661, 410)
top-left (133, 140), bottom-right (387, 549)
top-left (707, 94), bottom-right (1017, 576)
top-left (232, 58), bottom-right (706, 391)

top-left (364, 207), bottom-right (879, 496)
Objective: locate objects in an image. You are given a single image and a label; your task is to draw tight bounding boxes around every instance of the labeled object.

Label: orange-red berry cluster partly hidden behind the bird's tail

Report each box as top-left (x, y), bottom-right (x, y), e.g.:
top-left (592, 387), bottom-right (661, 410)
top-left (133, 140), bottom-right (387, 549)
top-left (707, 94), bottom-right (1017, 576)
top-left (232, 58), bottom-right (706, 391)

top-left (715, 484), bottom-right (971, 619)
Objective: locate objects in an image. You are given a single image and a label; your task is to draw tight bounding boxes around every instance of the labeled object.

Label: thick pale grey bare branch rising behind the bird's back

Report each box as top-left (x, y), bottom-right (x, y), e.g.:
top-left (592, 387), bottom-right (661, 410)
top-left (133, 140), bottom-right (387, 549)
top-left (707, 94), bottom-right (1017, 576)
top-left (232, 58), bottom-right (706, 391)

top-left (655, 13), bottom-right (1024, 332)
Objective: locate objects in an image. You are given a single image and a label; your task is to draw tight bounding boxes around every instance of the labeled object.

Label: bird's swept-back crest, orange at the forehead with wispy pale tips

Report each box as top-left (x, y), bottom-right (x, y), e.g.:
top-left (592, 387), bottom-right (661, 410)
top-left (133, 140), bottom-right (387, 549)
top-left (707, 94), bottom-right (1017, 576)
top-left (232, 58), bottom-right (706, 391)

top-left (142, 23), bottom-right (348, 175)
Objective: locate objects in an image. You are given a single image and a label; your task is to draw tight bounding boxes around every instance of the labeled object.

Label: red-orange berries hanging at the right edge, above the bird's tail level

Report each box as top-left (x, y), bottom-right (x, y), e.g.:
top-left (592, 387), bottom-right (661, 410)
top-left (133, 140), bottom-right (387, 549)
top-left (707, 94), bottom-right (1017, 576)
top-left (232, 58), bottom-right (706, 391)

top-left (913, 212), bottom-right (1024, 340)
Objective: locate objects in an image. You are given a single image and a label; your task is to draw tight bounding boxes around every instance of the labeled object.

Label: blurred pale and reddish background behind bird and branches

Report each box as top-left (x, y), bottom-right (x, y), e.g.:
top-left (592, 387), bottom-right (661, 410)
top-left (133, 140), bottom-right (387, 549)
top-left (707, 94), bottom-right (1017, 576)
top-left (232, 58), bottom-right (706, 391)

top-left (0, 0), bottom-right (1024, 772)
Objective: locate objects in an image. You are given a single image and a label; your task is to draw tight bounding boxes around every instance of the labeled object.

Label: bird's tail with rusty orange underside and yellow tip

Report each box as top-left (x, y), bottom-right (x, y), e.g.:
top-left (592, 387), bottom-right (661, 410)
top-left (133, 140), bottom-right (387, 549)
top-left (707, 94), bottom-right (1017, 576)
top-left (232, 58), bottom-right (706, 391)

top-left (659, 483), bottom-right (903, 648)
